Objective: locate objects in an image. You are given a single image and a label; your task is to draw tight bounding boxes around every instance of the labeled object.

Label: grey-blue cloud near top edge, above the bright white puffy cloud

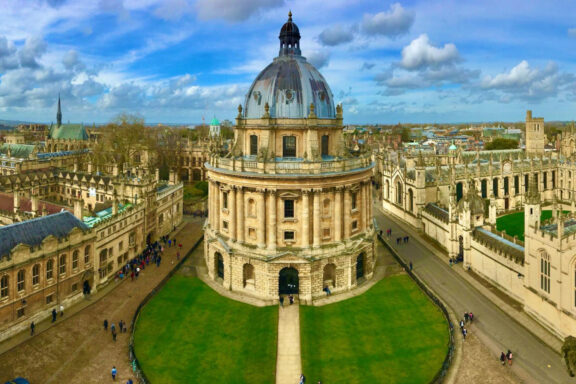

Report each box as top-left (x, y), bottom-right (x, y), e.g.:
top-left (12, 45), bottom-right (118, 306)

top-left (362, 3), bottom-right (414, 37)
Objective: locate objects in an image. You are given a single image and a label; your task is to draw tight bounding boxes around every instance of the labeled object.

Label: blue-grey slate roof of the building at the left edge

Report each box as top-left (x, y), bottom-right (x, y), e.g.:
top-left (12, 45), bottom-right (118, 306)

top-left (0, 211), bottom-right (88, 259)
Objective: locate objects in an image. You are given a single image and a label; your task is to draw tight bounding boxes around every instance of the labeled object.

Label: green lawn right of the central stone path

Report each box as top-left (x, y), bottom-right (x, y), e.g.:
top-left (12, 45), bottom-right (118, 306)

top-left (300, 275), bottom-right (449, 384)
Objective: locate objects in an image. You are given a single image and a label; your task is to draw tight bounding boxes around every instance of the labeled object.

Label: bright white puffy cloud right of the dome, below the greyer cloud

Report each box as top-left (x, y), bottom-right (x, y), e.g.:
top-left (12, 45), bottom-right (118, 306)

top-left (400, 34), bottom-right (460, 70)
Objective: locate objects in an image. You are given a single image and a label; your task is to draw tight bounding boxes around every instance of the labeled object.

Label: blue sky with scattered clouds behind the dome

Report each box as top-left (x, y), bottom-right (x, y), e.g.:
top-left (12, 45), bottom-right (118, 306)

top-left (0, 0), bottom-right (576, 123)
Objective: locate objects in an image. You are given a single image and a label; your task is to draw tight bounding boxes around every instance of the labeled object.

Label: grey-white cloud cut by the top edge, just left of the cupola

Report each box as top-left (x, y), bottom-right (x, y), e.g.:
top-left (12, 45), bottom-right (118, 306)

top-left (195, 0), bottom-right (284, 22)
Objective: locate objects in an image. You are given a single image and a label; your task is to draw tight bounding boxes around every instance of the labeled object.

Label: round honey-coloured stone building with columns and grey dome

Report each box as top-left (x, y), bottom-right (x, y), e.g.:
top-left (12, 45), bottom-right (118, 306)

top-left (205, 14), bottom-right (374, 303)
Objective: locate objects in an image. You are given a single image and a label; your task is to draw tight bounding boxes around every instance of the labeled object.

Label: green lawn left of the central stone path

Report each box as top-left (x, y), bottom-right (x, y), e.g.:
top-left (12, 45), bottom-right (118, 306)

top-left (134, 275), bottom-right (278, 384)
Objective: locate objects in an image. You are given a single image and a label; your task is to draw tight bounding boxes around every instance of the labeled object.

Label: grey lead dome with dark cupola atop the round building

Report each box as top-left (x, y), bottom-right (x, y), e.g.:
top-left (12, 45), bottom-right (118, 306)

top-left (244, 13), bottom-right (336, 119)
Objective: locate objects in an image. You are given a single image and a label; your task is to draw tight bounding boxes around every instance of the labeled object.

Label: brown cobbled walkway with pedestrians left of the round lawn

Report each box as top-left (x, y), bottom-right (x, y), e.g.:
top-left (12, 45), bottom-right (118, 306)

top-left (0, 218), bottom-right (203, 384)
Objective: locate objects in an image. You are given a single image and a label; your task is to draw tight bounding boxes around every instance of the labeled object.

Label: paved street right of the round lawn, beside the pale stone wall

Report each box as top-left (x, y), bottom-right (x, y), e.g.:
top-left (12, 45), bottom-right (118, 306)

top-left (374, 209), bottom-right (576, 384)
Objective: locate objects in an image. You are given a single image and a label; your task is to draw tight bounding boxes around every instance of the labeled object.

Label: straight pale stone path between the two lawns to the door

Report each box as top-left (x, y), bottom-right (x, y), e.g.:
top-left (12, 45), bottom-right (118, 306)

top-left (276, 299), bottom-right (302, 384)
